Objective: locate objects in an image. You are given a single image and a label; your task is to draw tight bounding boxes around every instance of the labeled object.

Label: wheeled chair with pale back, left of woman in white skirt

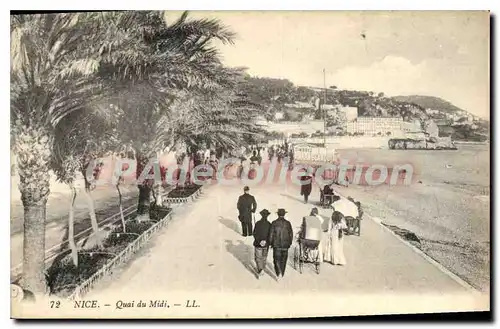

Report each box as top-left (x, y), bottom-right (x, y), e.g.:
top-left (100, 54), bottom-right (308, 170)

top-left (293, 216), bottom-right (322, 274)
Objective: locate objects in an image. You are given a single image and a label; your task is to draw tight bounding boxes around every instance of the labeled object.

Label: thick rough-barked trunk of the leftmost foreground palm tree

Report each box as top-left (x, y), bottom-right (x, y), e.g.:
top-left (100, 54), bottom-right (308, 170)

top-left (14, 127), bottom-right (51, 295)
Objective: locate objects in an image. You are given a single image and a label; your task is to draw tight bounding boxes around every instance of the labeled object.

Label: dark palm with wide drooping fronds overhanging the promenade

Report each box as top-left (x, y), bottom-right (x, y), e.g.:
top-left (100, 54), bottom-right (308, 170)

top-left (98, 12), bottom-right (237, 217)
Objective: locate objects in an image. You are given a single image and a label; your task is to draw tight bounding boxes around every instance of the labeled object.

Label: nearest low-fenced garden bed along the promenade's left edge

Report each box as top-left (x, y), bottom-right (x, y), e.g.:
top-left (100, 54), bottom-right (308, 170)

top-left (47, 207), bottom-right (171, 298)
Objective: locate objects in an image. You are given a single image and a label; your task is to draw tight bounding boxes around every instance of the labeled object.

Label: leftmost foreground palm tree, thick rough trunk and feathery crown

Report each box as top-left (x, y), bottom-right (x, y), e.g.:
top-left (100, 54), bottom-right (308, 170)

top-left (11, 13), bottom-right (122, 294)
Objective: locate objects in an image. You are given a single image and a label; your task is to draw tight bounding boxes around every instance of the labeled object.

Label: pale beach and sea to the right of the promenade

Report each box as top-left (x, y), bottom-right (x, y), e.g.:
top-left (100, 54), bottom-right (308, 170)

top-left (335, 145), bottom-right (490, 293)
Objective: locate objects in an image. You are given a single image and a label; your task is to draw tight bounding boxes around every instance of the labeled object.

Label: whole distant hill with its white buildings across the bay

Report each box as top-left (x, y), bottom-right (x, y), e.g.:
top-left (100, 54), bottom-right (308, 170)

top-left (239, 76), bottom-right (489, 141)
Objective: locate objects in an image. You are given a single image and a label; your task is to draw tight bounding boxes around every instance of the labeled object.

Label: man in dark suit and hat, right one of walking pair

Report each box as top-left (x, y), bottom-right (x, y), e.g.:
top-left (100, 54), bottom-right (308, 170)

top-left (269, 208), bottom-right (293, 281)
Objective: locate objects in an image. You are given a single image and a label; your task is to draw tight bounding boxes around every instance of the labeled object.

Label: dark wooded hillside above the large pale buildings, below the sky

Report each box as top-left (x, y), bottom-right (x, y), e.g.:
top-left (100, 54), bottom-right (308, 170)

top-left (238, 75), bottom-right (489, 141)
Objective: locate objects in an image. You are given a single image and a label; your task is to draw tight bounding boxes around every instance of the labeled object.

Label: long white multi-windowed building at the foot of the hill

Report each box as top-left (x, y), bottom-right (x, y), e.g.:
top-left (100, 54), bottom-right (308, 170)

top-left (347, 117), bottom-right (403, 136)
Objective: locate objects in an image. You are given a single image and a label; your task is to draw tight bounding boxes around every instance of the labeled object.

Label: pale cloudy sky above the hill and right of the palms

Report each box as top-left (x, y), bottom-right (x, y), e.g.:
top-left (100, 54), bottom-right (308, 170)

top-left (167, 11), bottom-right (490, 118)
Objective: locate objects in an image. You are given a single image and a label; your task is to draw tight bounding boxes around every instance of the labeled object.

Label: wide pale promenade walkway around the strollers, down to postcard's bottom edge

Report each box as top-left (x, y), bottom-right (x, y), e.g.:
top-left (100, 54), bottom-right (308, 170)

top-left (89, 178), bottom-right (488, 316)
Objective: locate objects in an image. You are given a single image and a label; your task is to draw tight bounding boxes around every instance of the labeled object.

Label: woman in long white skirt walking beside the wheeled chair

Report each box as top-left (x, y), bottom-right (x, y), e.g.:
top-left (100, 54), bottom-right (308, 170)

top-left (323, 211), bottom-right (347, 265)
